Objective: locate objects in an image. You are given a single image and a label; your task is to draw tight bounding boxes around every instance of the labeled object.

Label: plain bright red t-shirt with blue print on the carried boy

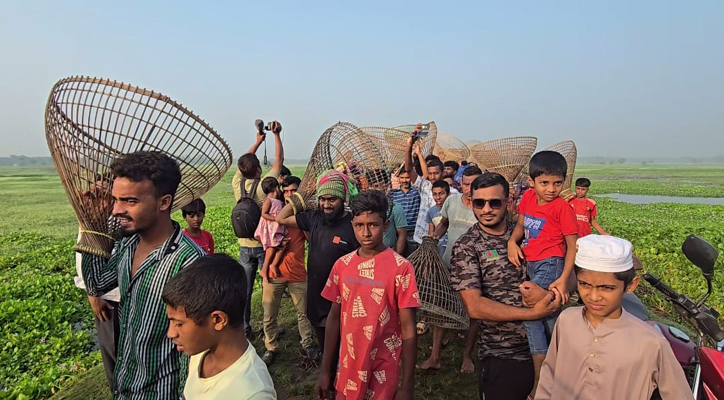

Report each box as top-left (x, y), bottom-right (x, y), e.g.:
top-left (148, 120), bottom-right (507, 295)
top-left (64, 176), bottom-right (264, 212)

top-left (518, 190), bottom-right (578, 261)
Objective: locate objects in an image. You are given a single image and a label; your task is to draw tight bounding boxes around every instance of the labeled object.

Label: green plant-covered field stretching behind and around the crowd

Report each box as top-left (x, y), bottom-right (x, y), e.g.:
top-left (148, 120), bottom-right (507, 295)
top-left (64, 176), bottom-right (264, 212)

top-left (0, 165), bottom-right (724, 400)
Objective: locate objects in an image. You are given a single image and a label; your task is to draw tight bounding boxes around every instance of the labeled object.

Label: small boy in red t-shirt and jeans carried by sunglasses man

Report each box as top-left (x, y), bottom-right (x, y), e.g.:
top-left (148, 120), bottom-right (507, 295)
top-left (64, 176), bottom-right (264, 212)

top-left (508, 151), bottom-right (578, 395)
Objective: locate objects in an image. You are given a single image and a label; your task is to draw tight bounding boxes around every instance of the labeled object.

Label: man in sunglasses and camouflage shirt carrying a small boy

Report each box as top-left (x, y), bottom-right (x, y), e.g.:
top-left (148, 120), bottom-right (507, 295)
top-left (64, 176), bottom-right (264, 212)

top-left (451, 172), bottom-right (561, 400)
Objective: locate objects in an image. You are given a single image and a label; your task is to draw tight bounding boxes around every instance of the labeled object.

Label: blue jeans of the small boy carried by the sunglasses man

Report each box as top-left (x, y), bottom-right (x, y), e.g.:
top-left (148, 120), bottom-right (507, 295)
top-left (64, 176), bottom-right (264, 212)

top-left (523, 257), bottom-right (564, 354)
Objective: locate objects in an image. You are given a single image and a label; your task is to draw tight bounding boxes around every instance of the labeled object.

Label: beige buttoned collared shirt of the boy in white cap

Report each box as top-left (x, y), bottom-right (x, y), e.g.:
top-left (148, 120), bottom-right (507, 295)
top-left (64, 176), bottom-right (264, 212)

top-left (535, 307), bottom-right (694, 400)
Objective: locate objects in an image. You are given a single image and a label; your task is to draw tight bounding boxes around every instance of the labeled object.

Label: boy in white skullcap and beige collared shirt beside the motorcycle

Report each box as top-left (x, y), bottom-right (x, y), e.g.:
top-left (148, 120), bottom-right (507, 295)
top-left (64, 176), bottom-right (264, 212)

top-left (535, 235), bottom-right (693, 400)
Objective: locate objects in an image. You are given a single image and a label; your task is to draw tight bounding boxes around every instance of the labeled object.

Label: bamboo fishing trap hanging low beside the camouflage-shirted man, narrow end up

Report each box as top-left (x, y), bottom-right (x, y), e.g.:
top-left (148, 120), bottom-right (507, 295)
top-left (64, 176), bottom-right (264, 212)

top-left (408, 237), bottom-right (470, 329)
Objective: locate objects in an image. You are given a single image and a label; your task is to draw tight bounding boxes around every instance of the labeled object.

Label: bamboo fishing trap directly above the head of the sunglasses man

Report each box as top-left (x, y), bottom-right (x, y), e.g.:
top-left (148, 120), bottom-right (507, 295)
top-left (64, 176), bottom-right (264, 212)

top-left (470, 136), bottom-right (538, 184)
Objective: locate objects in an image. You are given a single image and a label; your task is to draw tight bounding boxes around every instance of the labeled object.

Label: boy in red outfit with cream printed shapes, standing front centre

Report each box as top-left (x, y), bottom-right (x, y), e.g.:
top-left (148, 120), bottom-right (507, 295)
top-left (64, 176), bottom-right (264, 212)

top-left (316, 190), bottom-right (420, 400)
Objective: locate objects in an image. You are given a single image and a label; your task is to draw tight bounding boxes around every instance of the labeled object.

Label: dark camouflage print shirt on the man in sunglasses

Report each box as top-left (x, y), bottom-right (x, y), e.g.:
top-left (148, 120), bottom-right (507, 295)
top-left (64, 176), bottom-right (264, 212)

top-left (451, 222), bottom-right (530, 361)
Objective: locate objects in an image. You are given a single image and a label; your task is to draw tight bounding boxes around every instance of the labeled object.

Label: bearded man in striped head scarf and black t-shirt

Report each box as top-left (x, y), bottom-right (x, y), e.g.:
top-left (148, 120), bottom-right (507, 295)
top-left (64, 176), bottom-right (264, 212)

top-left (277, 170), bottom-right (359, 394)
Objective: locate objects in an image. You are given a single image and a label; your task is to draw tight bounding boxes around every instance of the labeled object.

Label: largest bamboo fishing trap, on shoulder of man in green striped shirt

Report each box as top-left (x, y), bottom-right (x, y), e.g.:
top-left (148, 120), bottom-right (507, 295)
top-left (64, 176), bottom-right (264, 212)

top-left (45, 76), bottom-right (232, 257)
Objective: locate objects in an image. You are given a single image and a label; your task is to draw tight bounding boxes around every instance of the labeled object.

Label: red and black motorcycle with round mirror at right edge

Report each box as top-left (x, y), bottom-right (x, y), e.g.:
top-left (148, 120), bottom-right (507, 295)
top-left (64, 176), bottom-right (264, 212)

top-left (642, 235), bottom-right (724, 400)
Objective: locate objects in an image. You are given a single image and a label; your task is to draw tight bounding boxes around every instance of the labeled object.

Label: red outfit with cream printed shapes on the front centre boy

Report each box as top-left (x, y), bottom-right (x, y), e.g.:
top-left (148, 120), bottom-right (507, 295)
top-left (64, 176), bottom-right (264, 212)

top-left (322, 248), bottom-right (420, 400)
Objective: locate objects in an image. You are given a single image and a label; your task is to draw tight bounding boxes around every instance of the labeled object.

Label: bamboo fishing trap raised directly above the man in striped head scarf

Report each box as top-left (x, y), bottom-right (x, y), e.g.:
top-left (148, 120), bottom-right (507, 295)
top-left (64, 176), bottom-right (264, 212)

top-left (290, 122), bottom-right (390, 211)
